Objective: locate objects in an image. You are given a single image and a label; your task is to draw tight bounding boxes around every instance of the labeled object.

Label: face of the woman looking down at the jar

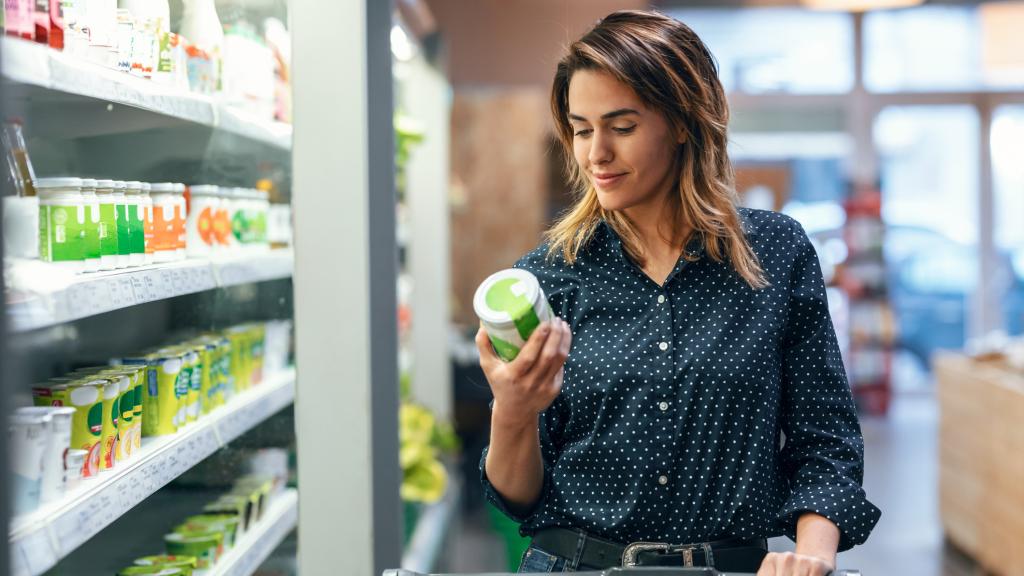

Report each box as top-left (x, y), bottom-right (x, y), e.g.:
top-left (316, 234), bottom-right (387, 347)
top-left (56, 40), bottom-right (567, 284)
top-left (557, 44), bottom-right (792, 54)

top-left (568, 70), bottom-right (682, 213)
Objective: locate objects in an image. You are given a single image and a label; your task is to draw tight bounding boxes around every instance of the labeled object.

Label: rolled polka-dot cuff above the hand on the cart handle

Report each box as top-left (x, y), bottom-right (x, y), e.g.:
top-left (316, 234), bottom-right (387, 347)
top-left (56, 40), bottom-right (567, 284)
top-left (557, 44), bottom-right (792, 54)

top-left (776, 484), bottom-right (882, 552)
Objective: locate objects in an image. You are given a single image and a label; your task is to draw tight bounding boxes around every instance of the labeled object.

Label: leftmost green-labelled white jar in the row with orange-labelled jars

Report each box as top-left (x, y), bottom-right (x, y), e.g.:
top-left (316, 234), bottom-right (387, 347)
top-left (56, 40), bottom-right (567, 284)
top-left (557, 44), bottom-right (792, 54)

top-left (34, 177), bottom-right (86, 273)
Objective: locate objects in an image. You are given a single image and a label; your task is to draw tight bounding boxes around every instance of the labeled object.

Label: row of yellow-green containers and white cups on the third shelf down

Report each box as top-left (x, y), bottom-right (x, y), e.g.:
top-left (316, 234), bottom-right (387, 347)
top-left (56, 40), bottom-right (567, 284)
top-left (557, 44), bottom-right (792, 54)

top-left (11, 321), bottom-right (291, 513)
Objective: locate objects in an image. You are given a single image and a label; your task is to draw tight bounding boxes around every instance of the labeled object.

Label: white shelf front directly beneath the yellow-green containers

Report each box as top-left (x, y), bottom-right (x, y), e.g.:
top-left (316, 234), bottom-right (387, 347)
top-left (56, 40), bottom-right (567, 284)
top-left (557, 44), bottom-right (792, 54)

top-left (10, 370), bottom-right (295, 576)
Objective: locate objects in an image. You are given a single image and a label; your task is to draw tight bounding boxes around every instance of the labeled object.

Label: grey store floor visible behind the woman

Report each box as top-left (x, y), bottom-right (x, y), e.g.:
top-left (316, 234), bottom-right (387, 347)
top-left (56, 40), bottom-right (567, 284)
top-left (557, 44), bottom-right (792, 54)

top-left (451, 383), bottom-right (976, 576)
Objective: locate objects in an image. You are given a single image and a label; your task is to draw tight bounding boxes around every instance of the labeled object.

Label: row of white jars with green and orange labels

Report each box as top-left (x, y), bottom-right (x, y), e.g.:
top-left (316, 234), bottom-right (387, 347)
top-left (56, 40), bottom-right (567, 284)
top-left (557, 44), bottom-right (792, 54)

top-left (4, 177), bottom-right (280, 273)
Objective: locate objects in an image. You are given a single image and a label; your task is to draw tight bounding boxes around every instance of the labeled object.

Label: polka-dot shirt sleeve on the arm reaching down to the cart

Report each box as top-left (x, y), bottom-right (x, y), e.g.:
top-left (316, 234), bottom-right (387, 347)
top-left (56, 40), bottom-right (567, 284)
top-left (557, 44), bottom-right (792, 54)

top-left (778, 219), bottom-right (881, 551)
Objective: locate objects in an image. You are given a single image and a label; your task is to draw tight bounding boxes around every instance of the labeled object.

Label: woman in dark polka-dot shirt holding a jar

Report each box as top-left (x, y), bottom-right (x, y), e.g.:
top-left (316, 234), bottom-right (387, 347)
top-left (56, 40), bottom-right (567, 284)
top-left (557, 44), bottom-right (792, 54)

top-left (476, 11), bottom-right (880, 576)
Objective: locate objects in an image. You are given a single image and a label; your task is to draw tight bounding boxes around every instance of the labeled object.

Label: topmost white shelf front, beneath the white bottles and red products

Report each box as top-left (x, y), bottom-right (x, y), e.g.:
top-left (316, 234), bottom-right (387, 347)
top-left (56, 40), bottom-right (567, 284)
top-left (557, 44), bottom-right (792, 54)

top-left (0, 37), bottom-right (292, 150)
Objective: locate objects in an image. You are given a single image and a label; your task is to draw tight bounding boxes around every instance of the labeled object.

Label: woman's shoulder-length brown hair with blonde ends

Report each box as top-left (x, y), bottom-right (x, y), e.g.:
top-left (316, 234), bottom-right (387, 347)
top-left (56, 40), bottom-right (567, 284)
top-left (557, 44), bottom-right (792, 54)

top-left (545, 10), bottom-right (768, 289)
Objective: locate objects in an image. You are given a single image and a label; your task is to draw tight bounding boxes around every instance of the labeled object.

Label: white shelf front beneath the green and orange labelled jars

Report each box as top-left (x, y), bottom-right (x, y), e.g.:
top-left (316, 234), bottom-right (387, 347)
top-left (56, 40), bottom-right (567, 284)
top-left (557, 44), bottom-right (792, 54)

top-left (7, 250), bottom-right (294, 332)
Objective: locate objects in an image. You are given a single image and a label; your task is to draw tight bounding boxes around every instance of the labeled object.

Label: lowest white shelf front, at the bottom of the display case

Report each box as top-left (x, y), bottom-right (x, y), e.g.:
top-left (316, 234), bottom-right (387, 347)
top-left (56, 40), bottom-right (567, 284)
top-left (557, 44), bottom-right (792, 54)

top-left (209, 483), bottom-right (299, 576)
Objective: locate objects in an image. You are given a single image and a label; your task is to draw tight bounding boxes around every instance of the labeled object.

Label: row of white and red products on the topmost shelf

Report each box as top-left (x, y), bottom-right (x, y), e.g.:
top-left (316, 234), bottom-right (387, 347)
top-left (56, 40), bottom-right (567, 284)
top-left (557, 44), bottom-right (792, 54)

top-left (4, 0), bottom-right (291, 121)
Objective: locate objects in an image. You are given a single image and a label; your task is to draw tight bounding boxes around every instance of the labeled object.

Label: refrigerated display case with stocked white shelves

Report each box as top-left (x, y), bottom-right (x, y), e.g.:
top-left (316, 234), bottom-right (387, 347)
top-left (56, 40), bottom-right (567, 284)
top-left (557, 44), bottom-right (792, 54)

top-left (0, 1), bottom-right (298, 576)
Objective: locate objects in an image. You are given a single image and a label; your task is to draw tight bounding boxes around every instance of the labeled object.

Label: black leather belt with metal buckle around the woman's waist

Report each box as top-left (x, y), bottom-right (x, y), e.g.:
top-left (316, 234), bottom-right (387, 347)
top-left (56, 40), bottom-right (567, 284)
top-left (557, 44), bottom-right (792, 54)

top-left (531, 528), bottom-right (768, 573)
